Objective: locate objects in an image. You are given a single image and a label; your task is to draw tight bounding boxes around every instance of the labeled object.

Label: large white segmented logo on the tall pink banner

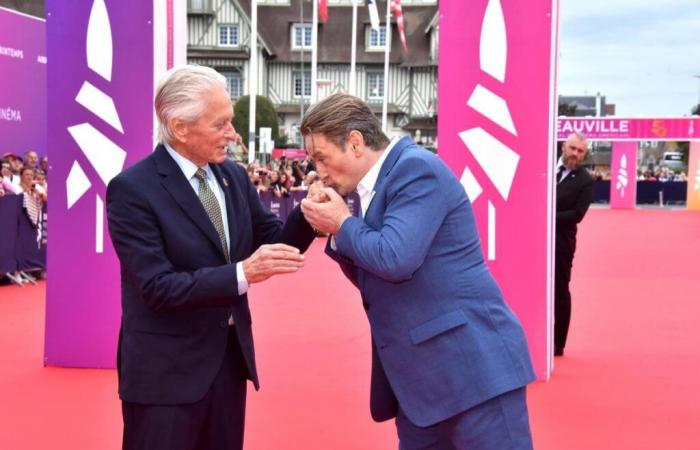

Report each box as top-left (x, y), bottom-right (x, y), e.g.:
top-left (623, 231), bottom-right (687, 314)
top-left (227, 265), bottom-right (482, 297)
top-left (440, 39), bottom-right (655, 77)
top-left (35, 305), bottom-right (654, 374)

top-left (459, 0), bottom-right (520, 261)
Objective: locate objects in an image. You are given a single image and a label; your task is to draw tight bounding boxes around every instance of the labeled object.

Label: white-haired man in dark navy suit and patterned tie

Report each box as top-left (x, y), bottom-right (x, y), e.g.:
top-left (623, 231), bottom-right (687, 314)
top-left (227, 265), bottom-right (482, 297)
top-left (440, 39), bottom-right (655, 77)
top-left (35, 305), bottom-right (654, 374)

top-left (107, 66), bottom-right (314, 450)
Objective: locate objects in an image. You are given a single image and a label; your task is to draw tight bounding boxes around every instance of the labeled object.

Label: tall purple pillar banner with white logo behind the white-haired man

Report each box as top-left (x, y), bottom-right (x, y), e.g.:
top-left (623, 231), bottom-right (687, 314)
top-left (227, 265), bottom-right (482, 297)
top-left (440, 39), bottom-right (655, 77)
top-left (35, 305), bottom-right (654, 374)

top-left (45, 0), bottom-right (186, 367)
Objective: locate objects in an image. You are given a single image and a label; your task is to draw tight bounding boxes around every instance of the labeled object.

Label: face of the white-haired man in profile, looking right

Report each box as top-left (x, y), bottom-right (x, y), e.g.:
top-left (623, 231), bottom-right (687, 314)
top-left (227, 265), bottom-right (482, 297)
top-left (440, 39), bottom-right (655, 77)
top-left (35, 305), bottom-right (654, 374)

top-left (183, 87), bottom-right (236, 166)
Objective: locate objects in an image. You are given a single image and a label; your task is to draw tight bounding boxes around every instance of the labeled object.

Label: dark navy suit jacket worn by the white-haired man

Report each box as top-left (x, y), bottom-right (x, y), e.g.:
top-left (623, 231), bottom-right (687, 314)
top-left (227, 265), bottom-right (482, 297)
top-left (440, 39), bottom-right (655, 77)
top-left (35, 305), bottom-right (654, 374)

top-left (107, 146), bottom-right (314, 405)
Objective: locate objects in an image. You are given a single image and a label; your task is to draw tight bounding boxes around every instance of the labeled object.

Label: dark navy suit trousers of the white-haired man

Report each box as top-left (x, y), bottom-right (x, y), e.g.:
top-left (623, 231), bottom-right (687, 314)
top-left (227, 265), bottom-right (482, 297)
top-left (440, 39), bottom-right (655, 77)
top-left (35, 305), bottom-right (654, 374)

top-left (122, 327), bottom-right (247, 450)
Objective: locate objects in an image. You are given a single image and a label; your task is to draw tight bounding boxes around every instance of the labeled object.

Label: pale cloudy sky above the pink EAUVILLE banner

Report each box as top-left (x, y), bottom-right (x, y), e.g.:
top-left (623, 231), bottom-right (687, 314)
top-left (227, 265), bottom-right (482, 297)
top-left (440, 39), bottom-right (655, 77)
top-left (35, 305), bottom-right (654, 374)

top-left (559, 0), bottom-right (700, 117)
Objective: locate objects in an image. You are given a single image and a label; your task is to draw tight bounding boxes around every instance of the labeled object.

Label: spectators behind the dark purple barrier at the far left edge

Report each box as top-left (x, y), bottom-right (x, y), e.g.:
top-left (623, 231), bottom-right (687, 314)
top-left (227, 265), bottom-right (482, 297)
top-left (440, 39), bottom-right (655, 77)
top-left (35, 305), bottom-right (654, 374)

top-left (0, 151), bottom-right (49, 285)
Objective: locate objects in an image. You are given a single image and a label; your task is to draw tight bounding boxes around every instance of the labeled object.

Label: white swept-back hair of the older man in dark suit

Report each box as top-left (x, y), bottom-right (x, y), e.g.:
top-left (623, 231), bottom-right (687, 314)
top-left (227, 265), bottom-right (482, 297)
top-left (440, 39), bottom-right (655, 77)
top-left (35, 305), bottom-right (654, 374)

top-left (153, 65), bottom-right (228, 143)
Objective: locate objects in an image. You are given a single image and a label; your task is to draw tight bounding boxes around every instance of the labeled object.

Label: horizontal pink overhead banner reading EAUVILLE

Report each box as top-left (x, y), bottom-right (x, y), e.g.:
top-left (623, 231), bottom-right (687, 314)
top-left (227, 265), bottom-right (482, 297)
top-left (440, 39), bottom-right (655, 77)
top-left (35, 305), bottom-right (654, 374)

top-left (557, 117), bottom-right (700, 141)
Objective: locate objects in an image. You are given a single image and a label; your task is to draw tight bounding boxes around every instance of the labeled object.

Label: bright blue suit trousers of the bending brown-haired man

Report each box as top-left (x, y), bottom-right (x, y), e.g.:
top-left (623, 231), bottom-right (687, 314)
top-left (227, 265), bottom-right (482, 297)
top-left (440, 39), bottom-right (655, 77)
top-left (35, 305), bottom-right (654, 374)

top-left (396, 387), bottom-right (532, 450)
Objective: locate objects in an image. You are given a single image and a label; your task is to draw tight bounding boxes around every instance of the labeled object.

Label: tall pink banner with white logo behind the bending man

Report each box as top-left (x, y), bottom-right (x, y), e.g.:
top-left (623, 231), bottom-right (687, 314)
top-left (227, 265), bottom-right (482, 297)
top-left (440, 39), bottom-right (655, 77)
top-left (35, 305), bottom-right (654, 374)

top-left (438, 0), bottom-right (557, 379)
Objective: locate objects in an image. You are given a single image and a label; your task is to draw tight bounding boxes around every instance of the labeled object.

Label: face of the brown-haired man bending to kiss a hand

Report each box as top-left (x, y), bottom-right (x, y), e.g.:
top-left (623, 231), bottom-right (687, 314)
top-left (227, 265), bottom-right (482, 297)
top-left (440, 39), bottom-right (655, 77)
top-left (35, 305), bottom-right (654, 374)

top-left (304, 133), bottom-right (363, 195)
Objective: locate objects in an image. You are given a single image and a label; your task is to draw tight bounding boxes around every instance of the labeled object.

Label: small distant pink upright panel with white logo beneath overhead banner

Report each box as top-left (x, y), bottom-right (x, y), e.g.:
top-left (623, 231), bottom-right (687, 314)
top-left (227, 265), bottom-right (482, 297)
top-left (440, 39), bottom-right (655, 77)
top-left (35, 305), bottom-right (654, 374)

top-left (610, 142), bottom-right (637, 209)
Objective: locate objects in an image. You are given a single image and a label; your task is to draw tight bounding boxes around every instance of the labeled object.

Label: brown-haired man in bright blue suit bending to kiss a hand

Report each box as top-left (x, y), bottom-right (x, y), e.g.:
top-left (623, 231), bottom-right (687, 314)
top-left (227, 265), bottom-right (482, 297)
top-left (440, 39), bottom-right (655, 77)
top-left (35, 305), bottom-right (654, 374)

top-left (301, 94), bottom-right (534, 450)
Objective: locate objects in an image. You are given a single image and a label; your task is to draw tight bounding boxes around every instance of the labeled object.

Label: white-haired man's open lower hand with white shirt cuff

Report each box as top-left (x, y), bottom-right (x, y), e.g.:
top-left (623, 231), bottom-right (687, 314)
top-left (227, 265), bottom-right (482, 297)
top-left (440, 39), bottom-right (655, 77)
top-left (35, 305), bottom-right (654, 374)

top-left (243, 244), bottom-right (304, 284)
